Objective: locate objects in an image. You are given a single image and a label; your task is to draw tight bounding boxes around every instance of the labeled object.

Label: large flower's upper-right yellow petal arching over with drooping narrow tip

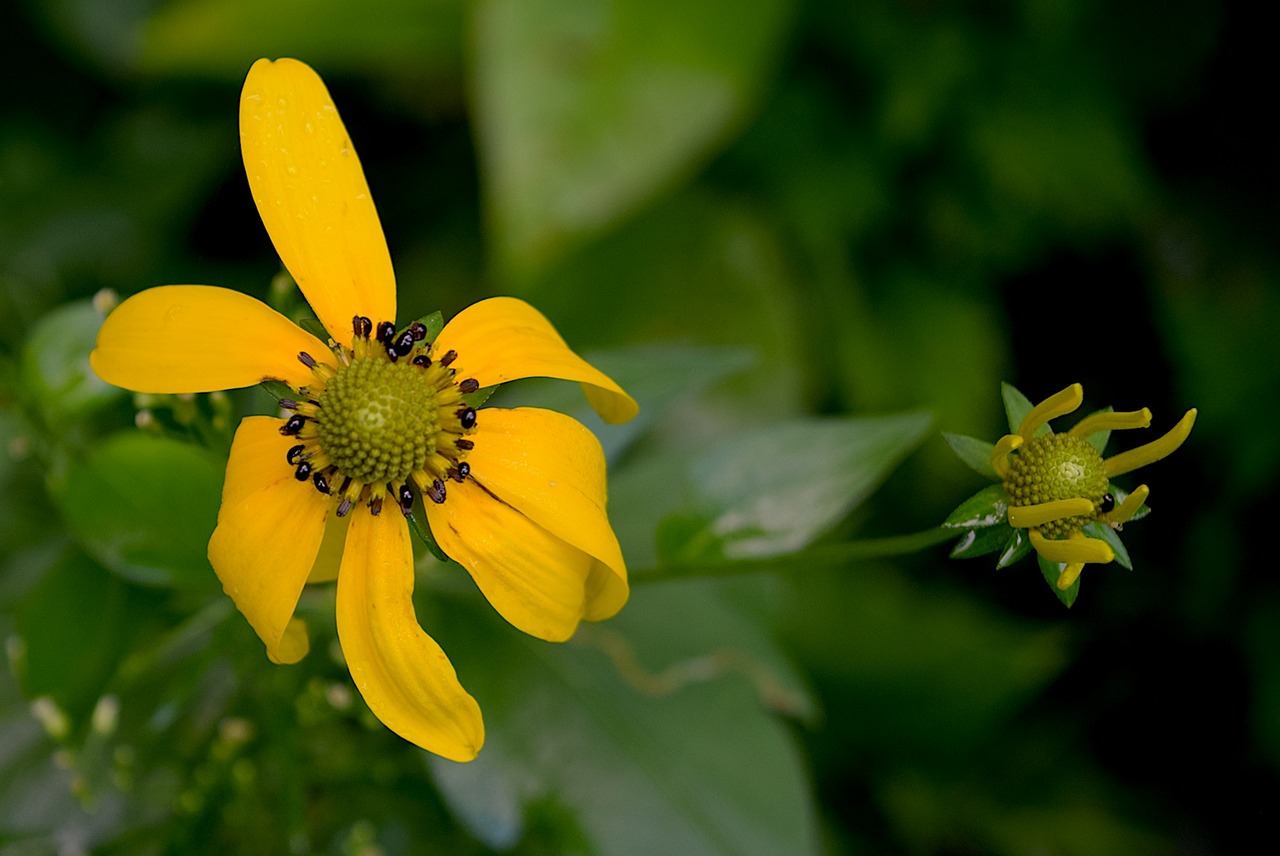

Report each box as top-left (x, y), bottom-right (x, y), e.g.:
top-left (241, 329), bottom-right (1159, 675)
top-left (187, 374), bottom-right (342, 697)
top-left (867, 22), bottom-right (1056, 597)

top-left (436, 297), bottom-right (640, 422)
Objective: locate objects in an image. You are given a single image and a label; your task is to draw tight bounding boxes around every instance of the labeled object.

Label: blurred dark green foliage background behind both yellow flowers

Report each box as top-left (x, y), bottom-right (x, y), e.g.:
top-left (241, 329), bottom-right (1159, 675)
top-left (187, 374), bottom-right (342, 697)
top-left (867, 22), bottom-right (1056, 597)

top-left (0, 0), bottom-right (1280, 856)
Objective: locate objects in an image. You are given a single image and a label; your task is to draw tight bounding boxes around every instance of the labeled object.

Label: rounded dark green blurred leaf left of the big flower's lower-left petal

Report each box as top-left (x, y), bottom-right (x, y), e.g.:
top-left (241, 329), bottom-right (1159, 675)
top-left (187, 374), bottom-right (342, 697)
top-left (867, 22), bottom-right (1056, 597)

top-left (52, 431), bottom-right (222, 586)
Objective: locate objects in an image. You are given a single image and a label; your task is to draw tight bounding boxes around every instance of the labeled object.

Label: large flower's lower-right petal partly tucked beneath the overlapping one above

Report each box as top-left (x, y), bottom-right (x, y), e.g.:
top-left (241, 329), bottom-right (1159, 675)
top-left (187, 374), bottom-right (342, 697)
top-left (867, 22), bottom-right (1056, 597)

top-left (426, 480), bottom-right (599, 642)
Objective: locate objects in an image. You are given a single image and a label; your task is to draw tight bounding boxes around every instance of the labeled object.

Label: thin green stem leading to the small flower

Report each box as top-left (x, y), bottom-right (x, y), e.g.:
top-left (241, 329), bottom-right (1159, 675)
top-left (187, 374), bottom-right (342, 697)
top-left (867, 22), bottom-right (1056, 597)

top-left (630, 526), bottom-right (956, 585)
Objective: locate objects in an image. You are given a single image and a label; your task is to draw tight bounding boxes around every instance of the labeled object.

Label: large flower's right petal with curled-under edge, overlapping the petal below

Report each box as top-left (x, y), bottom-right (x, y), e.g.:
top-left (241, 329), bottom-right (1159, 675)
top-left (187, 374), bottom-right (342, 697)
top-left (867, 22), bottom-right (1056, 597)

top-left (467, 407), bottom-right (628, 621)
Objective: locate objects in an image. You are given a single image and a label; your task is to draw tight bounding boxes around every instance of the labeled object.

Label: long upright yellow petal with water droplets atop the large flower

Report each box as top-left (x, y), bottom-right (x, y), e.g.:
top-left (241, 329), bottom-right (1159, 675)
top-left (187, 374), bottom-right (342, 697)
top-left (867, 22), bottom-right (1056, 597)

top-left (241, 59), bottom-right (396, 345)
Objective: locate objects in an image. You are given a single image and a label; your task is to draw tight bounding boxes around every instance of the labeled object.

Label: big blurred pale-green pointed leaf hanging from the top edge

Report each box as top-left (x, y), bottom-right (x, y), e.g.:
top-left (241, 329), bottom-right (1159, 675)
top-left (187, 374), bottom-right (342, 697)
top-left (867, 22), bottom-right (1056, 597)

top-left (472, 0), bottom-right (788, 275)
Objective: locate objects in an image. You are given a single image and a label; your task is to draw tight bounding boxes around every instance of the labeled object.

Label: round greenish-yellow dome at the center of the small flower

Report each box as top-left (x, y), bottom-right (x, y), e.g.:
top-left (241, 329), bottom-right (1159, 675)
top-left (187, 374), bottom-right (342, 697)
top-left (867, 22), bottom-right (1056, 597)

top-left (1005, 434), bottom-right (1107, 537)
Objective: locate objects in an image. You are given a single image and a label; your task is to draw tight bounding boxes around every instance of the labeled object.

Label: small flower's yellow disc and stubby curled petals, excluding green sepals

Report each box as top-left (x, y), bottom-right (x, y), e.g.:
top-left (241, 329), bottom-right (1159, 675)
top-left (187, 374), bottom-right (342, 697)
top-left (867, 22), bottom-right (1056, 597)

top-left (991, 384), bottom-right (1196, 590)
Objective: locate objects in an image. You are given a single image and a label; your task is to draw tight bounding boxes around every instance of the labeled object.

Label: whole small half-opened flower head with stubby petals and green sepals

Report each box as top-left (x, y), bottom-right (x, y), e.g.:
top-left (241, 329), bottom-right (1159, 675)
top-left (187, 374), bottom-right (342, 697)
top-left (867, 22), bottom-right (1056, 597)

top-left (946, 384), bottom-right (1196, 605)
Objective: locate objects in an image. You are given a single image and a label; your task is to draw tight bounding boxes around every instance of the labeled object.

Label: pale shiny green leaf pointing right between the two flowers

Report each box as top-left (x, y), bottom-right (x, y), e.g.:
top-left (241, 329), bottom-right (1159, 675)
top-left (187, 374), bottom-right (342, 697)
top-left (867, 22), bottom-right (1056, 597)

top-left (675, 413), bottom-right (933, 558)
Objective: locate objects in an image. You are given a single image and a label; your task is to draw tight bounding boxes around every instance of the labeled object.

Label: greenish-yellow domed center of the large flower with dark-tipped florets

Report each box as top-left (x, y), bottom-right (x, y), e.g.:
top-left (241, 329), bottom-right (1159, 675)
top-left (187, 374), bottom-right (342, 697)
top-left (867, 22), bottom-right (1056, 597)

top-left (280, 316), bottom-right (480, 517)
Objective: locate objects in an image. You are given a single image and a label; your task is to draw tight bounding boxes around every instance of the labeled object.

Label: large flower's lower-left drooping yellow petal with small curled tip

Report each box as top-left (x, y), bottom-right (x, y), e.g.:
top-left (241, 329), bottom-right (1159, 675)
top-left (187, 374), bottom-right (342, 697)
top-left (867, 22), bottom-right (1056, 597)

top-left (209, 416), bottom-right (332, 663)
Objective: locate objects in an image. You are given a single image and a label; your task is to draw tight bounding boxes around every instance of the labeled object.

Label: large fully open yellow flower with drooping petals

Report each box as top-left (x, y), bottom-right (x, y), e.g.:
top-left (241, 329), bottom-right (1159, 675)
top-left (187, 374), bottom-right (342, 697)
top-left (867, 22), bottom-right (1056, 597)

top-left (91, 59), bottom-right (637, 760)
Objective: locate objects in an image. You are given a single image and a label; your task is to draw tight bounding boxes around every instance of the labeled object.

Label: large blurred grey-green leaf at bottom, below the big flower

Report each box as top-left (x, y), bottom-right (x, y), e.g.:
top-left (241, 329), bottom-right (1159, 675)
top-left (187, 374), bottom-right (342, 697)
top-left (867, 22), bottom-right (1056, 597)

top-left (429, 583), bottom-right (817, 856)
